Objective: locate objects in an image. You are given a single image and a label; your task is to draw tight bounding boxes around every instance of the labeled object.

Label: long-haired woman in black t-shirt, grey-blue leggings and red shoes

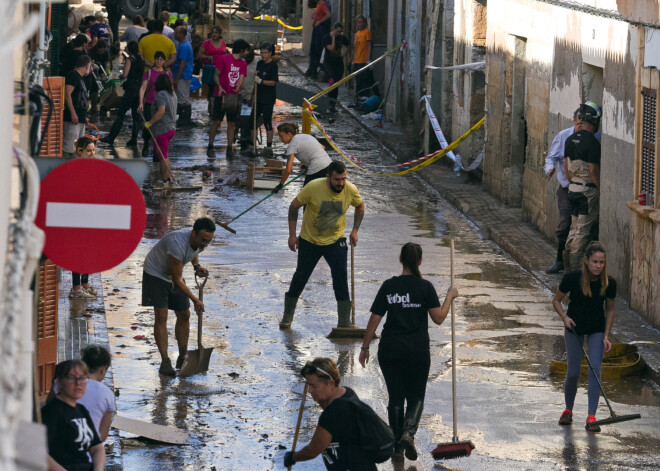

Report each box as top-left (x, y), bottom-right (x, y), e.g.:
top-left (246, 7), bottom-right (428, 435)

top-left (552, 242), bottom-right (616, 432)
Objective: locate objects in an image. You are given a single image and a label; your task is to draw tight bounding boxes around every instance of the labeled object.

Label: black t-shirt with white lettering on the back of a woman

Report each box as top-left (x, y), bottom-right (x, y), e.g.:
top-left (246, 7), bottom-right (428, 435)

top-left (371, 275), bottom-right (440, 358)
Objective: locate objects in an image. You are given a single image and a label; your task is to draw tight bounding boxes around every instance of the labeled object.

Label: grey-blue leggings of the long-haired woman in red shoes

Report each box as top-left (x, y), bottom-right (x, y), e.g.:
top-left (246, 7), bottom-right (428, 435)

top-left (564, 329), bottom-right (605, 415)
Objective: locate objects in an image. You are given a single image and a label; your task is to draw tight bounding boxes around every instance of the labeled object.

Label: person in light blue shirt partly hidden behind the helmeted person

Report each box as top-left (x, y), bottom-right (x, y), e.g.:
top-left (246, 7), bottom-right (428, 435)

top-left (545, 108), bottom-right (580, 274)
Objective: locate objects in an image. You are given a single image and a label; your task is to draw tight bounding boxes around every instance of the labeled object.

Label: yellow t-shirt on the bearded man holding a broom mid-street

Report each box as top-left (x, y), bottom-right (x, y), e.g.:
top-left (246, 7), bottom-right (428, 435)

top-left (297, 178), bottom-right (362, 245)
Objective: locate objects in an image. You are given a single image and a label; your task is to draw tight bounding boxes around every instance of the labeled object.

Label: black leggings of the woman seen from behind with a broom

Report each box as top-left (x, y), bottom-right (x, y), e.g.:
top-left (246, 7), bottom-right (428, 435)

top-left (378, 351), bottom-right (431, 407)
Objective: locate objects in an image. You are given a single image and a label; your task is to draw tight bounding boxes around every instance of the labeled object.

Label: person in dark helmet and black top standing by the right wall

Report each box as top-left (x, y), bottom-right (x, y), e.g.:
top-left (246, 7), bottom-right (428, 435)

top-left (564, 101), bottom-right (601, 271)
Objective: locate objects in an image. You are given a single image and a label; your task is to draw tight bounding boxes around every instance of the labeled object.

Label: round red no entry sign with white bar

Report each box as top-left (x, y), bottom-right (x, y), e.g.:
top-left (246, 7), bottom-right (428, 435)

top-left (35, 159), bottom-right (147, 273)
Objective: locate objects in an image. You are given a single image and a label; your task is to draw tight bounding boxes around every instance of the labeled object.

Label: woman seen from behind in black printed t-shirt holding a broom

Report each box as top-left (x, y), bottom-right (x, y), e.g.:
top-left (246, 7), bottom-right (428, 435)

top-left (360, 242), bottom-right (458, 462)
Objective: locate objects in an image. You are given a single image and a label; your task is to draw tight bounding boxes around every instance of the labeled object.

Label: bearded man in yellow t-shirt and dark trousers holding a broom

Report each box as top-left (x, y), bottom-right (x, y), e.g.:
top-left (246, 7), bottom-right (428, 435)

top-left (280, 160), bottom-right (364, 329)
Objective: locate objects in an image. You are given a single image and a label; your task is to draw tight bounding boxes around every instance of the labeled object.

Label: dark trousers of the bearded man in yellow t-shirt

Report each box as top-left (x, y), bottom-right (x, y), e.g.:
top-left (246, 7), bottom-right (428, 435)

top-left (286, 237), bottom-right (351, 301)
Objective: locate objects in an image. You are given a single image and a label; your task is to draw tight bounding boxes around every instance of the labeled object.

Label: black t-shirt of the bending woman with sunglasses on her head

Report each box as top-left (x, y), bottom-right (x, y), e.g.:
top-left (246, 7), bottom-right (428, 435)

top-left (319, 388), bottom-right (377, 471)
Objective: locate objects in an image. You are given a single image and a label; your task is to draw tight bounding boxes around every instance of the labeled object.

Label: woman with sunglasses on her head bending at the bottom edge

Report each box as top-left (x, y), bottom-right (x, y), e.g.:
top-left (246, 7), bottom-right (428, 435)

top-left (284, 358), bottom-right (377, 471)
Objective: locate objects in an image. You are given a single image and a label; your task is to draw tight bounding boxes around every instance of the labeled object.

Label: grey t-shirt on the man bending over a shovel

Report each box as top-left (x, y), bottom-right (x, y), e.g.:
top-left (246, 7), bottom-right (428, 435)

top-left (144, 229), bottom-right (204, 283)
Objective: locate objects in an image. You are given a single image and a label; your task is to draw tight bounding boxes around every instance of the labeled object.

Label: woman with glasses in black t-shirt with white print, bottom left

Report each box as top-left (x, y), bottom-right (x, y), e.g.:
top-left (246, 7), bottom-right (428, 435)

top-left (41, 360), bottom-right (105, 471)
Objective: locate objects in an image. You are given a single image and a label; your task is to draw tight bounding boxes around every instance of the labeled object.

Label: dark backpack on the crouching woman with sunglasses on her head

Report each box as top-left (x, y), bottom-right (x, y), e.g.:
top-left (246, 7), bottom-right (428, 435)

top-left (342, 396), bottom-right (394, 463)
